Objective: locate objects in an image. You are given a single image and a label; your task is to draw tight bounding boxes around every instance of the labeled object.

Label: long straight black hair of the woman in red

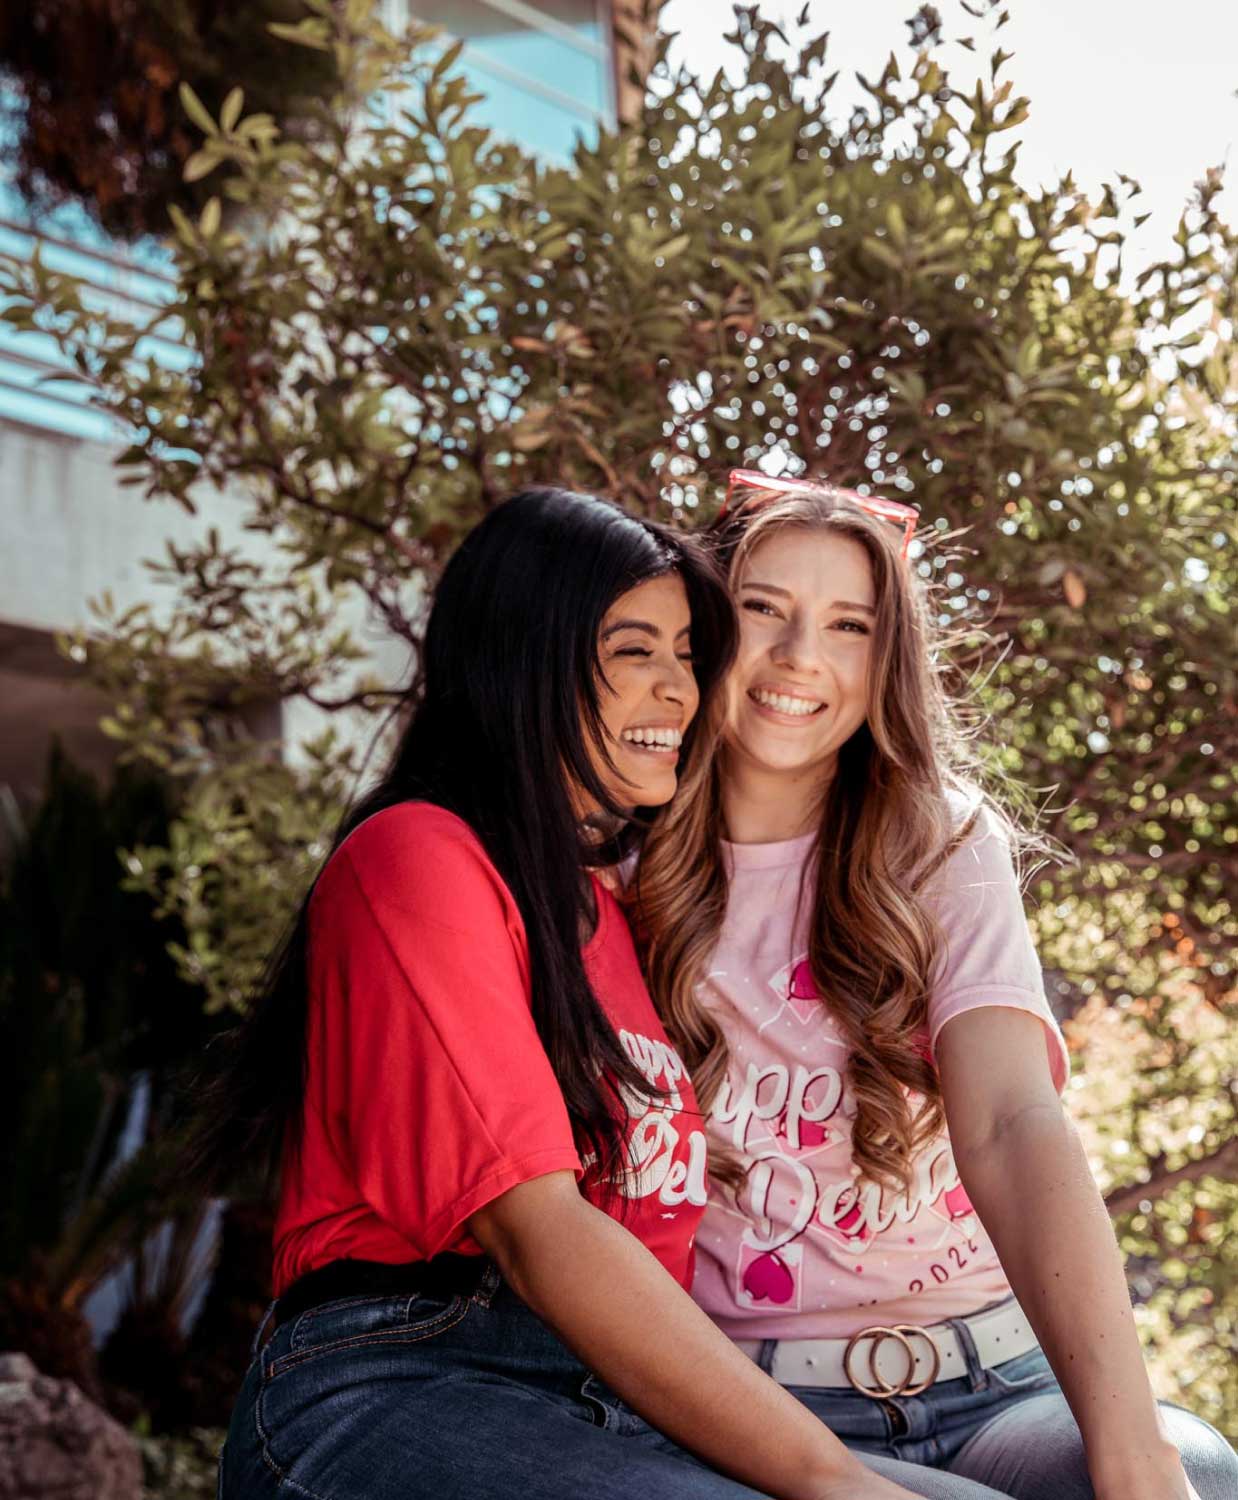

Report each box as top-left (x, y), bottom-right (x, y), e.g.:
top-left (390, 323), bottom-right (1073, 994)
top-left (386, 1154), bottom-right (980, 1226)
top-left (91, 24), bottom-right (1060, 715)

top-left (192, 489), bottom-right (735, 1185)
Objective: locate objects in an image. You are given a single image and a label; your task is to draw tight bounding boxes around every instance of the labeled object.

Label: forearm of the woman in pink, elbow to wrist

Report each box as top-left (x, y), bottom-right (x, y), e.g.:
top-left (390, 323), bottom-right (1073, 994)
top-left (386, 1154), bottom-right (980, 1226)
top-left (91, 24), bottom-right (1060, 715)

top-left (956, 1104), bottom-right (1176, 1490)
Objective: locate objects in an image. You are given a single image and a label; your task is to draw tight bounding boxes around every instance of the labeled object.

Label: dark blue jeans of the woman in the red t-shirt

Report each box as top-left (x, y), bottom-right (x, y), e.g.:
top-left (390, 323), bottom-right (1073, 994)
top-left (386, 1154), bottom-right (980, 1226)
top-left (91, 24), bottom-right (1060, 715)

top-left (219, 1268), bottom-right (1014, 1500)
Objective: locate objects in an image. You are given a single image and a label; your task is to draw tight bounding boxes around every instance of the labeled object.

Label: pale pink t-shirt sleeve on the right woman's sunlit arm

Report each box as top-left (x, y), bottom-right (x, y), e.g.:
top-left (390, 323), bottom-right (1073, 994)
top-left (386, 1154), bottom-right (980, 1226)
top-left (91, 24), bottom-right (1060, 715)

top-left (924, 809), bottom-right (1070, 1092)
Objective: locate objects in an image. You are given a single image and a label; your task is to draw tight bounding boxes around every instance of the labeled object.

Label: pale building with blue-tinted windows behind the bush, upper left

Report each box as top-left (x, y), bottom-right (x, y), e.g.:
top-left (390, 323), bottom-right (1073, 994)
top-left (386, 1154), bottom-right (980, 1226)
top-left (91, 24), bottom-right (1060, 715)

top-left (0, 0), bottom-right (641, 803)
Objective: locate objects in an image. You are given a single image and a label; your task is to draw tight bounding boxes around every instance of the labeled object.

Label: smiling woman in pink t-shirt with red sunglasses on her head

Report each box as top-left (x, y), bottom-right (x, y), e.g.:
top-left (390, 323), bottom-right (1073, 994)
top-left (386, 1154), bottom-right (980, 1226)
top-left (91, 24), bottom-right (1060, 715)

top-left (629, 471), bottom-right (1238, 1500)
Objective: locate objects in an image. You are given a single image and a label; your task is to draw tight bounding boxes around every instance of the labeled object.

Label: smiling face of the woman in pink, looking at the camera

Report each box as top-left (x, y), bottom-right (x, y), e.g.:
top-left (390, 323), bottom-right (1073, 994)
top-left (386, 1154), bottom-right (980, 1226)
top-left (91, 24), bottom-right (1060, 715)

top-left (725, 527), bottom-right (876, 795)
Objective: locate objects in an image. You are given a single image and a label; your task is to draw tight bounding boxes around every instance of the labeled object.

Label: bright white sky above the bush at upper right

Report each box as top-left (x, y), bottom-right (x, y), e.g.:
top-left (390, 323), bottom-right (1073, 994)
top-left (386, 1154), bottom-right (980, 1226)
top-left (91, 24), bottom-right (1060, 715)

top-left (662, 0), bottom-right (1238, 270)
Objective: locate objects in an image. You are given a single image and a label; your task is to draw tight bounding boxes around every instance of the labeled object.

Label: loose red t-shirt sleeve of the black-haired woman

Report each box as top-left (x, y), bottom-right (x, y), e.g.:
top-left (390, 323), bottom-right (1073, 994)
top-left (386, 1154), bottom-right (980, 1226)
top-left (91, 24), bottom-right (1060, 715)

top-left (309, 804), bottom-right (581, 1259)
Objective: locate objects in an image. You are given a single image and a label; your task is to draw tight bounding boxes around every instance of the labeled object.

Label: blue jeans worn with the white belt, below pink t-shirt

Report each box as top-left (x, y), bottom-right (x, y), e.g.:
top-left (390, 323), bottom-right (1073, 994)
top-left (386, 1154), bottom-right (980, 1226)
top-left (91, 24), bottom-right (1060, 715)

top-left (759, 1325), bottom-right (1238, 1500)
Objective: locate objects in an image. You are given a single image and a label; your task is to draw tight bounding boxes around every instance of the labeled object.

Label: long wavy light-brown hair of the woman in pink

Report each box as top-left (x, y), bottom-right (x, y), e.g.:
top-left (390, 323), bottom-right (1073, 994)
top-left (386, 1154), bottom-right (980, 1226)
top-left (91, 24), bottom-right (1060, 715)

top-left (629, 491), bottom-right (1014, 1190)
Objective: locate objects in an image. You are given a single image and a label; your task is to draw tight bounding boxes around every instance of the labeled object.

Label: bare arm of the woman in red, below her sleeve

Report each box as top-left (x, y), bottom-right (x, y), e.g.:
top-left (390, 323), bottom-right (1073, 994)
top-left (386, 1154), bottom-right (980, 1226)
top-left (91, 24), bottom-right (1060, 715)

top-left (474, 1203), bottom-right (863, 1500)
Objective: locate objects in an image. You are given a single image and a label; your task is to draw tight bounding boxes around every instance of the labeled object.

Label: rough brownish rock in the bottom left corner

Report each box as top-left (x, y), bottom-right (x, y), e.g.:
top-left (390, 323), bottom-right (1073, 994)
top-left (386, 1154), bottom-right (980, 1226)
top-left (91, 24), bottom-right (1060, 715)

top-left (0, 1355), bottom-right (143, 1500)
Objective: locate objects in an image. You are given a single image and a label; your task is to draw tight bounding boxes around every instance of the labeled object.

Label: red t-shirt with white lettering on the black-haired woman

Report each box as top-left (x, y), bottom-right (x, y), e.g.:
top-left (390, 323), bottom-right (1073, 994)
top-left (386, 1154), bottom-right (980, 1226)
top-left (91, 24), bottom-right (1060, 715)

top-left (275, 803), bottom-right (707, 1295)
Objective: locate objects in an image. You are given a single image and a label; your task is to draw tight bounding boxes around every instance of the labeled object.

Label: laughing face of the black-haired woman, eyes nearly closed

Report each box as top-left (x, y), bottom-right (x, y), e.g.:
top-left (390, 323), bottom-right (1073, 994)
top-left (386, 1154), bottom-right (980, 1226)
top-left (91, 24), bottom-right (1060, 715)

top-left (594, 573), bottom-right (699, 807)
